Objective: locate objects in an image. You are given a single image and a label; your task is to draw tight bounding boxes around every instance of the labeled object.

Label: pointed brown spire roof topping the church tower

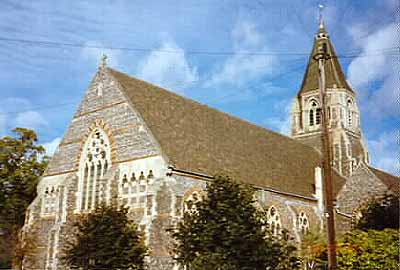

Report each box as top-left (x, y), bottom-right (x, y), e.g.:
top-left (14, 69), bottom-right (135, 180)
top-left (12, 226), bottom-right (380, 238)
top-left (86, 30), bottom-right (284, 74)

top-left (298, 25), bottom-right (354, 96)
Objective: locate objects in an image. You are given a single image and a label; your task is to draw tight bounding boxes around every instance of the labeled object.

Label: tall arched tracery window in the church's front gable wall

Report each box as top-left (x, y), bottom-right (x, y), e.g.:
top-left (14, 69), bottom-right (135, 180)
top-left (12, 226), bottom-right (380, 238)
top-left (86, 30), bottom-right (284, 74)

top-left (77, 128), bottom-right (111, 211)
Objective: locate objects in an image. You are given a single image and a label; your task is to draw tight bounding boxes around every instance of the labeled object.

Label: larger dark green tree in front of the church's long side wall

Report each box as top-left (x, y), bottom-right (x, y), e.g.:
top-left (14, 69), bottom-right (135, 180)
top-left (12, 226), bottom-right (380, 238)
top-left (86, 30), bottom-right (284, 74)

top-left (169, 176), bottom-right (295, 270)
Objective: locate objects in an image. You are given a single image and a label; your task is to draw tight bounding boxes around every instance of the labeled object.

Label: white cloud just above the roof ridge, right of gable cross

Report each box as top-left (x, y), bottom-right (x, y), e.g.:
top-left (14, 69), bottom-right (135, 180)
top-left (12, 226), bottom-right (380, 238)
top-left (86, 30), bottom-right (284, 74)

top-left (136, 40), bottom-right (199, 93)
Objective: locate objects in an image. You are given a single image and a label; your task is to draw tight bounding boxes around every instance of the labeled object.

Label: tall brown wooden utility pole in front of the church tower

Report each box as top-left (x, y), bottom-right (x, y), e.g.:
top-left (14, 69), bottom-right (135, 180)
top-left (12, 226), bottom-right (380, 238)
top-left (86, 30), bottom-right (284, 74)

top-left (313, 42), bottom-right (337, 270)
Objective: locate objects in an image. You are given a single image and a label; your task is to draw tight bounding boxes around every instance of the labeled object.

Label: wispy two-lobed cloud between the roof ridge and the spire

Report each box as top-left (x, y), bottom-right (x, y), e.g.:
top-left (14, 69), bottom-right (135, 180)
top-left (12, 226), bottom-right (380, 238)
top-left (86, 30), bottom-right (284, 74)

top-left (204, 21), bottom-right (277, 88)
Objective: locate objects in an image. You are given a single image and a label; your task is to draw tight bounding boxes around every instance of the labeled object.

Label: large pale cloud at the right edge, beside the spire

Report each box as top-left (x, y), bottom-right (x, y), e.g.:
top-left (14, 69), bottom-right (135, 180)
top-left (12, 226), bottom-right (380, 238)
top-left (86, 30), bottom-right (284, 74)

top-left (347, 24), bottom-right (399, 118)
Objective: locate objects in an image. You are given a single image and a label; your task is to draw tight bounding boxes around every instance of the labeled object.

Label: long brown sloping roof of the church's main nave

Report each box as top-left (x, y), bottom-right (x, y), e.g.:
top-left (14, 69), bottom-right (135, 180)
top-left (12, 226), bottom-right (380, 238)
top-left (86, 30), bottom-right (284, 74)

top-left (109, 69), bottom-right (320, 196)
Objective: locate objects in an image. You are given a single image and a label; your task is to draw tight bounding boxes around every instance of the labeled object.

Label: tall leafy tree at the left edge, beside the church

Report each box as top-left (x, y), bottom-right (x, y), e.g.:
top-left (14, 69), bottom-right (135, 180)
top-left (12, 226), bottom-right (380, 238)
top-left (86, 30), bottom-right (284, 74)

top-left (0, 128), bottom-right (47, 267)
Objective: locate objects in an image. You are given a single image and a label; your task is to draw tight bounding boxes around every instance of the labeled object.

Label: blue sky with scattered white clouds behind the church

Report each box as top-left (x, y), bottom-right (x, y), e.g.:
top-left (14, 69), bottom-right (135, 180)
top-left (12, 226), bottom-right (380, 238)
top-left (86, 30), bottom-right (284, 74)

top-left (0, 0), bottom-right (400, 175)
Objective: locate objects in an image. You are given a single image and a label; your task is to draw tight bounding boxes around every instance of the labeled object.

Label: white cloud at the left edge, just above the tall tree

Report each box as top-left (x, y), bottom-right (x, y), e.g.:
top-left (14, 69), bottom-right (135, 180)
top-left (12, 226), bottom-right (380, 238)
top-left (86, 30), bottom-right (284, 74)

top-left (0, 97), bottom-right (48, 136)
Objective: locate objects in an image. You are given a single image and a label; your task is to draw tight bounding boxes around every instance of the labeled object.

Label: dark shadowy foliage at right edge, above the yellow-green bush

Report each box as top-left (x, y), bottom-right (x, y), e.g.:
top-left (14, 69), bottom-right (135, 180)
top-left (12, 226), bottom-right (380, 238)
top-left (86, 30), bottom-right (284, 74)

top-left (356, 194), bottom-right (400, 230)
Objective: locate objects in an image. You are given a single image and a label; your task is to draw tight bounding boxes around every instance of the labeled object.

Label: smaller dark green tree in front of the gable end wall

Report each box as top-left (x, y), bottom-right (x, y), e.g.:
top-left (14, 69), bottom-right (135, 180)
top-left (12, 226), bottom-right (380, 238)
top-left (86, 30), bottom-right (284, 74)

top-left (62, 204), bottom-right (147, 270)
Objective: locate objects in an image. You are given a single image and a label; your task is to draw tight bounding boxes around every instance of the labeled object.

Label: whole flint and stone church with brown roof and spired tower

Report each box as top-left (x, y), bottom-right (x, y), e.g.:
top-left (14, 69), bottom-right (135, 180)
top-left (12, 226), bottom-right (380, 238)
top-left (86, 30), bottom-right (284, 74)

top-left (24, 21), bottom-right (399, 270)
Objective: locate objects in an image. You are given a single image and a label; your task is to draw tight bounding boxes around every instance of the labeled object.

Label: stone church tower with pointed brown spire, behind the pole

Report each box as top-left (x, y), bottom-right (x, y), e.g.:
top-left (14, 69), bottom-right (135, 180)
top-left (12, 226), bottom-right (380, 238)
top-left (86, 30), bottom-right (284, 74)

top-left (291, 20), bottom-right (369, 176)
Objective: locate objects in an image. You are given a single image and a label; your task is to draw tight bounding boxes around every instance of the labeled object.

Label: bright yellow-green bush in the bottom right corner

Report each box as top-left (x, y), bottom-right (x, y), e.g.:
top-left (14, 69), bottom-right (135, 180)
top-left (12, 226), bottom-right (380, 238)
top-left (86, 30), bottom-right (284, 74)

top-left (337, 229), bottom-right (400, 270)
